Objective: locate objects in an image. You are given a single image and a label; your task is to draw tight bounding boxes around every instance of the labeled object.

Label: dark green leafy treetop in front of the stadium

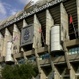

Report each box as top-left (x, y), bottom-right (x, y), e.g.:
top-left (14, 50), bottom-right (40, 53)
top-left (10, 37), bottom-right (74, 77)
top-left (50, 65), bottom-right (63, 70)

top-left (2, 63), bottom-right (38, 79)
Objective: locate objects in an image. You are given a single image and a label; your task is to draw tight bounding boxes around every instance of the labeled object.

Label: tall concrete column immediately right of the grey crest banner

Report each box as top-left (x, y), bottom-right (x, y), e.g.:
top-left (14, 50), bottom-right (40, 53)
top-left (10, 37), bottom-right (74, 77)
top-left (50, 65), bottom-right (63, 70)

top-left (33, 14), bottom-right (41, 73)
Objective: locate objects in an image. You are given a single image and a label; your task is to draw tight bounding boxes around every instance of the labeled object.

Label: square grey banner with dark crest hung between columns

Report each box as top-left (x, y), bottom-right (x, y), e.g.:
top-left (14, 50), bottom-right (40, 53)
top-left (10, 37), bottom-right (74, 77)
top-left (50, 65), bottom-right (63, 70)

top-left (21, 25), bottom-right (34, 46)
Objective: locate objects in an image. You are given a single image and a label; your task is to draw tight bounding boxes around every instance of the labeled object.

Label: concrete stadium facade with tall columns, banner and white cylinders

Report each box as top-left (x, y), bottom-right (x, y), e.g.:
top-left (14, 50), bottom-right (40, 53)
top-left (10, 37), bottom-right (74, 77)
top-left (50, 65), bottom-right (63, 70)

top-left (0, 0), bottom-right (79, 79)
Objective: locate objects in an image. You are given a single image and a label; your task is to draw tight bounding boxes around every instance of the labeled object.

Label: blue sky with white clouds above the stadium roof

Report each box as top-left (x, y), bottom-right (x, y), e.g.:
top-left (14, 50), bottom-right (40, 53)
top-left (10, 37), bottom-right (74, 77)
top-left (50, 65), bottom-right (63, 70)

top-left (0, 0), bottom-right (29, 20)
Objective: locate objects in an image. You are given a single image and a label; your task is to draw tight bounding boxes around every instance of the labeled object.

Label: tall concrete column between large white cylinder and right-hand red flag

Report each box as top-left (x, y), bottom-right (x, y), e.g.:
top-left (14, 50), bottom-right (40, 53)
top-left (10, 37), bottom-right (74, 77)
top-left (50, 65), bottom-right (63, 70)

top-left (60, 3), bottom-right (70, 69)
